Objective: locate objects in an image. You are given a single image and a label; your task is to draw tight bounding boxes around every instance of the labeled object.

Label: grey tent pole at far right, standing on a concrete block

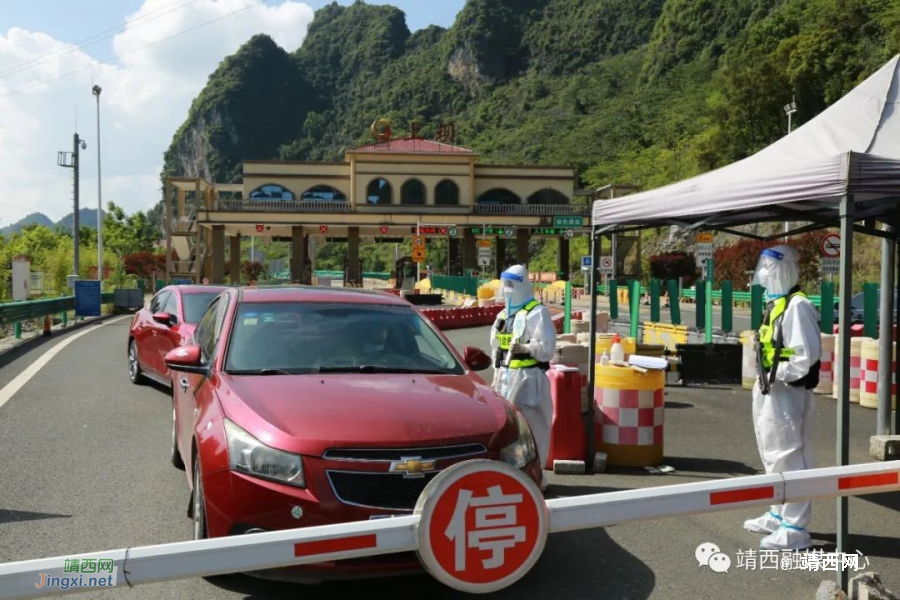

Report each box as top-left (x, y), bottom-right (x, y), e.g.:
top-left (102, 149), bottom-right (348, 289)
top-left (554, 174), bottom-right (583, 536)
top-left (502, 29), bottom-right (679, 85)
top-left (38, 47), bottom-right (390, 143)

top-left (875, 224), bottom-right (896, 435)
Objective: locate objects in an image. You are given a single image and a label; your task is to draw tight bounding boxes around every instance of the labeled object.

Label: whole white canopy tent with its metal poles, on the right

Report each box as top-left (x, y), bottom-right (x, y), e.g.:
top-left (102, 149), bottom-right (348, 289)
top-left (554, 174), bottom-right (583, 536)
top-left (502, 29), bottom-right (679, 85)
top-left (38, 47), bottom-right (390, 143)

top-left (588, 55), bottom-right (900, 590)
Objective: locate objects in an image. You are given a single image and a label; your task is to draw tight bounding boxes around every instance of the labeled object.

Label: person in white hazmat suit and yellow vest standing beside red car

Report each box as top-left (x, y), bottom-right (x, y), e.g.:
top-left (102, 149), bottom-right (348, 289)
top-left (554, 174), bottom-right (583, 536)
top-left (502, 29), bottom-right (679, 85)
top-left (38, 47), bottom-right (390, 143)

top-left (491, 265), bottom-right (556, 489)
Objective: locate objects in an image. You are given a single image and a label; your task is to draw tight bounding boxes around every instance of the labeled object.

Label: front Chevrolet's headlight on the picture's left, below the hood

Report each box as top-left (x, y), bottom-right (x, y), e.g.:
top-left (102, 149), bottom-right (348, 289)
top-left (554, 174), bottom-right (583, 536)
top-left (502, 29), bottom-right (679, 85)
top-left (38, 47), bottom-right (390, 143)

top-left (225, 419), bottom-right (306, 487)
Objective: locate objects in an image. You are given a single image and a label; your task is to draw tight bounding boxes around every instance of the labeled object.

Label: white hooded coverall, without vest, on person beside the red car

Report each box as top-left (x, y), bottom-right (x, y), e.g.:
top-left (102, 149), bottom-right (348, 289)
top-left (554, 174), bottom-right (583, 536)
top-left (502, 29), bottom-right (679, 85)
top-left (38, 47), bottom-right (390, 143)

top-left (491, 265), bottom-right (556, 484)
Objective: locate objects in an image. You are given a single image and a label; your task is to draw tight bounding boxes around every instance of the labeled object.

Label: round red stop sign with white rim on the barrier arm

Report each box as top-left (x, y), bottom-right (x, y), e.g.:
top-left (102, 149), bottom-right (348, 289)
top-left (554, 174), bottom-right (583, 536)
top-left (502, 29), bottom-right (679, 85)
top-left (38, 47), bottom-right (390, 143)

top-left (416, 460), bottom-right (548, 593)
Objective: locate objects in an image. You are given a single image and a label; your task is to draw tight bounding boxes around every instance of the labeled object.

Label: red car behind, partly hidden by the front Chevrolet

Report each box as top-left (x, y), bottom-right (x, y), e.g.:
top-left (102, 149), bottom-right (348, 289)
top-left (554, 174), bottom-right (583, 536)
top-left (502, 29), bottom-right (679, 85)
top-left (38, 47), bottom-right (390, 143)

top-left (128, 285), bottom-right (226, 387)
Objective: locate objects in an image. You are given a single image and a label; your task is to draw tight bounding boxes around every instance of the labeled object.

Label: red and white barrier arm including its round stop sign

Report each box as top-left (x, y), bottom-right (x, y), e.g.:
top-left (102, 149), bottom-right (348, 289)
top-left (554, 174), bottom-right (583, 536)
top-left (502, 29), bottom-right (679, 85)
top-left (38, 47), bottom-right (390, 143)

top-left (0, 460), bottom-right (900, 599)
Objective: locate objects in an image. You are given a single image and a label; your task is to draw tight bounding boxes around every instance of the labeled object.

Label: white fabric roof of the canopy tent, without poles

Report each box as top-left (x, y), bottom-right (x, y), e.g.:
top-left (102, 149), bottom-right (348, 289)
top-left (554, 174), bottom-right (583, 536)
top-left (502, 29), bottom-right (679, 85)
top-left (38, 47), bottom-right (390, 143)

top-left (593, 55), bottom-right (900, 230)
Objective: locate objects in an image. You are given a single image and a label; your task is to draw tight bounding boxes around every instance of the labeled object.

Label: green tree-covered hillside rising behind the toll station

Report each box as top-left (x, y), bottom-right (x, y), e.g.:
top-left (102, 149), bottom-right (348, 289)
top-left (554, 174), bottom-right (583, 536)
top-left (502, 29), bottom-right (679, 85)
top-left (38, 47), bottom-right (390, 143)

top-left (164, 0), bottom-right (900, 276)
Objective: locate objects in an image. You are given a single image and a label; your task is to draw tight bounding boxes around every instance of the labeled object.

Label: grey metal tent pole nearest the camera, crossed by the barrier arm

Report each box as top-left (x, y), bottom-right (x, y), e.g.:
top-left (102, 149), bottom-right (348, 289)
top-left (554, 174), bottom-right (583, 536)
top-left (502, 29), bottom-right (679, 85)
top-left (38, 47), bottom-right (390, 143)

top-left (836, 194), bottom-right (855, 591)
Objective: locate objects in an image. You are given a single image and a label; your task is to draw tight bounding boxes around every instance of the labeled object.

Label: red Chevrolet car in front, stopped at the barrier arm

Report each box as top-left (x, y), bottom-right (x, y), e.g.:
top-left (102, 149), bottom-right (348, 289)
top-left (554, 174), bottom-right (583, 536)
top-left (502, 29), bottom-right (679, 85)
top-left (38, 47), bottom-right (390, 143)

top-left (166, 287), bottom-right (541, 582)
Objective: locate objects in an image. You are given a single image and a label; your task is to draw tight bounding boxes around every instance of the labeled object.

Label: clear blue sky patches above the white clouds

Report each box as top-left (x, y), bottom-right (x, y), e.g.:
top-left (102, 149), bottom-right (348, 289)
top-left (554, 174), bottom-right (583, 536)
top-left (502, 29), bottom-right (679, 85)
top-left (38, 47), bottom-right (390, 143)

top-left (0, 0), bottom-right (465, 59)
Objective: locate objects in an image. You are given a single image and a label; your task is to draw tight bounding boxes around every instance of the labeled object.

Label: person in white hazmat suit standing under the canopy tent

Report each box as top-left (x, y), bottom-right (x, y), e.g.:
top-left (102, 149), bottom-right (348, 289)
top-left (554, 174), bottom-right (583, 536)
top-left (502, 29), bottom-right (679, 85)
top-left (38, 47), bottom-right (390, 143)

top-left (744, 246), bottom-right (822, 550)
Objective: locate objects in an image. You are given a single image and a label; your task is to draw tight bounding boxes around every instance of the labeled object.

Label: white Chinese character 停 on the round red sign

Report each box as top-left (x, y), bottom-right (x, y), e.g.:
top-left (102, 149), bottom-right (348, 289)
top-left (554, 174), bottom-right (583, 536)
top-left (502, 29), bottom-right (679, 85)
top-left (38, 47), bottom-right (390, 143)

top-left (444, 486), bottom-right (525, 571)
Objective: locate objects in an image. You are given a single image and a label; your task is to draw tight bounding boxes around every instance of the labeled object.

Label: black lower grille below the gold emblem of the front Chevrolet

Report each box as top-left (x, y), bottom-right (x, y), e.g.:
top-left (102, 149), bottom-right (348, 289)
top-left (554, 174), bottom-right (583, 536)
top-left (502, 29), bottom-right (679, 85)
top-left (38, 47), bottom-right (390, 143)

top-left (328, 471), bottom-right (438, 511)
